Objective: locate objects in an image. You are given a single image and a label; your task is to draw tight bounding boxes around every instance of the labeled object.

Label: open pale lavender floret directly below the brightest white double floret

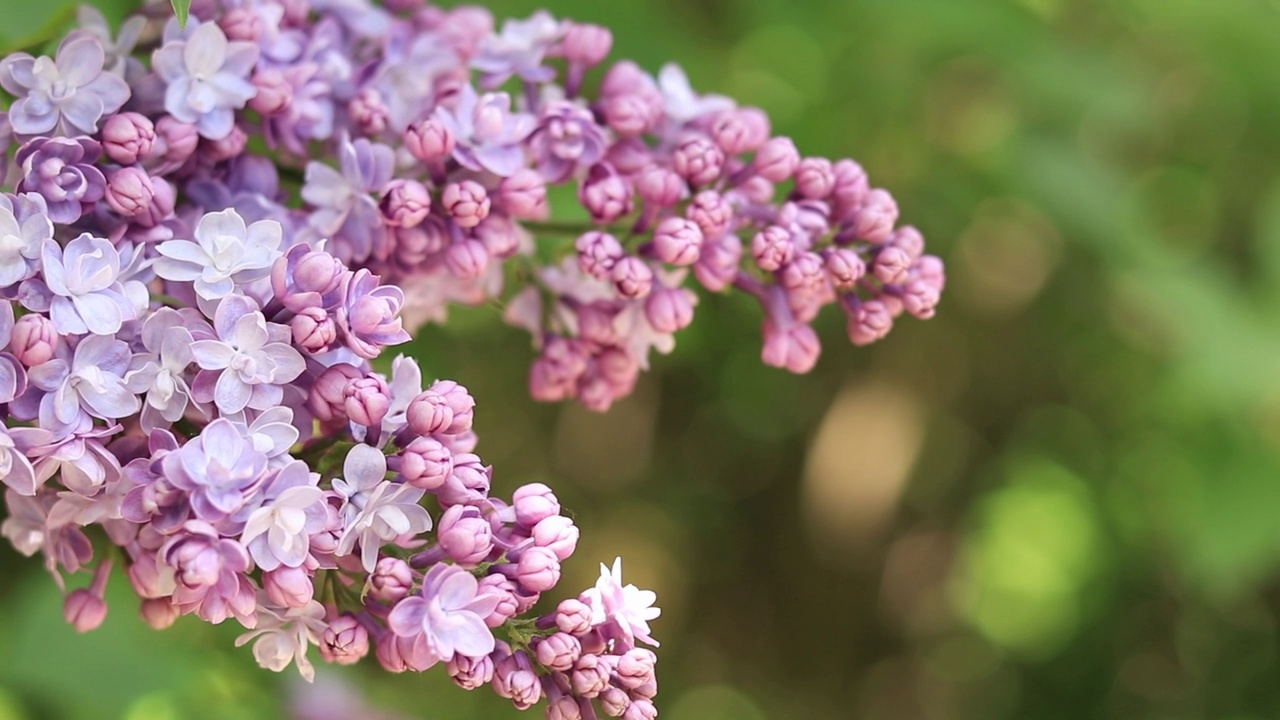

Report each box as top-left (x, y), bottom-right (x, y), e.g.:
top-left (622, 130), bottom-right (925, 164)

top-left (192, 295), bottom-right (306, 414)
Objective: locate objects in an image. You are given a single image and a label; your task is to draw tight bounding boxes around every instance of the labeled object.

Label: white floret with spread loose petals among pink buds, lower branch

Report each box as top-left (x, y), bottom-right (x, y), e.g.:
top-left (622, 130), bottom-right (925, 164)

top-left (333, 445), bottom-right (431, 573)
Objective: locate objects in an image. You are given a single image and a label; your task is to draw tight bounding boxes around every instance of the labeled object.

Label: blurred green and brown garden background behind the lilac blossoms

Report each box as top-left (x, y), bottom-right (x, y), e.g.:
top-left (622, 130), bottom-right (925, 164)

top-left (0, 0), bottom-right (1280, 720)
